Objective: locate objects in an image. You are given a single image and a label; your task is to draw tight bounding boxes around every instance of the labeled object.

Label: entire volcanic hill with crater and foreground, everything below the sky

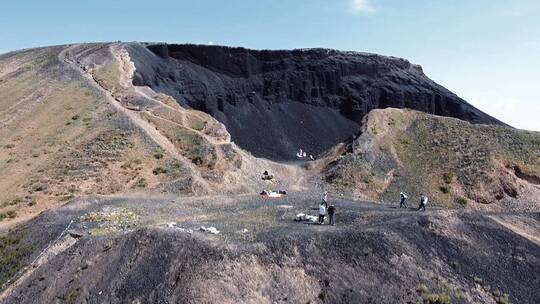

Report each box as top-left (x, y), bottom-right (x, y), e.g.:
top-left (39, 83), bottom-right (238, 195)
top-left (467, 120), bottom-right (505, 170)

top-left (0, 43), bottom-right (540, 304)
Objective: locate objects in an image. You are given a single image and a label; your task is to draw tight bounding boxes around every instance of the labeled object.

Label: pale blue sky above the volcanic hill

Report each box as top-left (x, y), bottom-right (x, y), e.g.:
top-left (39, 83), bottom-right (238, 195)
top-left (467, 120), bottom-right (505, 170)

top-left (0, 0), bottom-right (540, 131)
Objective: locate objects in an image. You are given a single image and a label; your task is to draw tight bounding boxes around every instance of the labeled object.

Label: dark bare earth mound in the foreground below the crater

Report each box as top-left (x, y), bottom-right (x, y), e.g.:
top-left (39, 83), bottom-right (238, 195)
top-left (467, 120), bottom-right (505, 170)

top-left (2, 192), bottom-right (540, 303)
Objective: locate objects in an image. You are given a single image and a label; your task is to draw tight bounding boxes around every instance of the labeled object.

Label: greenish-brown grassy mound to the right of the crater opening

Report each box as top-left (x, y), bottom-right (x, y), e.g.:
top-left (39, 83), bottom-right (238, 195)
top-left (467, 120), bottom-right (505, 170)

top-left (323, 109), bottom-right (540, 211)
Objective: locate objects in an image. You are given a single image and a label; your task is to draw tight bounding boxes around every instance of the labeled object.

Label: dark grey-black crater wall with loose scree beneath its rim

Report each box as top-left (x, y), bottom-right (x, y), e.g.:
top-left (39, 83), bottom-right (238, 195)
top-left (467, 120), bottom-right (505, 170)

top-left (128, 44), bottom-right (500, 160)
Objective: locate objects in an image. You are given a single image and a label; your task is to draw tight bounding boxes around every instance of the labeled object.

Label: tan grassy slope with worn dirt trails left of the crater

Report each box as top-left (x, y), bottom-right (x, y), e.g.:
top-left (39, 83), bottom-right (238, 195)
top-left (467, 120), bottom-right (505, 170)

top-left (0, 43), bottom-right (301, 227)
